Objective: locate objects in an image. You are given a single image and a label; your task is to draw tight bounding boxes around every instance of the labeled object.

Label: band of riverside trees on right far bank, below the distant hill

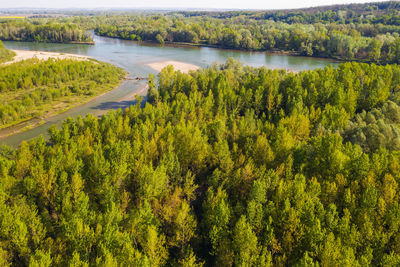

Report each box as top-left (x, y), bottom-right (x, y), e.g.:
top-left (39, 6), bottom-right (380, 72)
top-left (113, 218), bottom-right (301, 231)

top-left (95, 15), bottom-right (400, 63)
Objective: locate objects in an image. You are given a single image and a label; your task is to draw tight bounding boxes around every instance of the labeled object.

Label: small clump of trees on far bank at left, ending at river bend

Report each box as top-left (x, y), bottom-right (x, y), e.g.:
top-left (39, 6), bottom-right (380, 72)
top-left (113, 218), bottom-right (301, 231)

top-left (0, 20), bottom-right (93, 44)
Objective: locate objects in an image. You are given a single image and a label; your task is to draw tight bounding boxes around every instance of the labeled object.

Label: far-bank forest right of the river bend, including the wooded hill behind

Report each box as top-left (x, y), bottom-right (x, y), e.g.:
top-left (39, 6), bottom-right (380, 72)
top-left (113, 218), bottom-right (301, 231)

top-left (93, 2), bottom-right (400, 63)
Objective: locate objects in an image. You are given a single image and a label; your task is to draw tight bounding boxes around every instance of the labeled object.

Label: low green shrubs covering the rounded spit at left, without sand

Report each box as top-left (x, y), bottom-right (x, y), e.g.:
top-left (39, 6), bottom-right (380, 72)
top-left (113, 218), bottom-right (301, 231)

top-left (0, 59), bottom-right (124, 128)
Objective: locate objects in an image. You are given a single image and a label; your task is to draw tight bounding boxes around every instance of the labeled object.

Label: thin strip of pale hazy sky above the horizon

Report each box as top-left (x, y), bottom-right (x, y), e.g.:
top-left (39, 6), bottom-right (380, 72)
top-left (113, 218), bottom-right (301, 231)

top-left (0, 0), bottom-right (392, 9)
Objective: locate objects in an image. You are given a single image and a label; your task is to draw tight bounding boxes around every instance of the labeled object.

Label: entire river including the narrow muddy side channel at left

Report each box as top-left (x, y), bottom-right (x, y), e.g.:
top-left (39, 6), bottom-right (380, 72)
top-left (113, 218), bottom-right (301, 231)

top-left (0, 36), bottom-right (337, 146)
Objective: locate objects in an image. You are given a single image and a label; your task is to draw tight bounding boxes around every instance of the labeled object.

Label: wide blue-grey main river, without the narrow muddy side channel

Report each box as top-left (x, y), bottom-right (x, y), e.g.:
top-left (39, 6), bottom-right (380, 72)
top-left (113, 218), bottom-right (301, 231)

top-left (5, 36), bottom-right (337, 76)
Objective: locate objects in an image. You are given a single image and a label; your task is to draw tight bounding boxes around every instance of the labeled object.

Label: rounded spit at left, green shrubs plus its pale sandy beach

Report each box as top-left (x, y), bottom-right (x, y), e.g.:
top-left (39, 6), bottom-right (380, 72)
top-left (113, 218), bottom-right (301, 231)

top-left (0, 56), bottom-right (127, 140)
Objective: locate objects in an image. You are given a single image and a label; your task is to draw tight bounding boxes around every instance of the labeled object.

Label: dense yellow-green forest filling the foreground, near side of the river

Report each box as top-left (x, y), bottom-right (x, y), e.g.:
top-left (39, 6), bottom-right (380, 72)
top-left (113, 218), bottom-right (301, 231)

top-left (0, 61), bottom-right (400, 266)
